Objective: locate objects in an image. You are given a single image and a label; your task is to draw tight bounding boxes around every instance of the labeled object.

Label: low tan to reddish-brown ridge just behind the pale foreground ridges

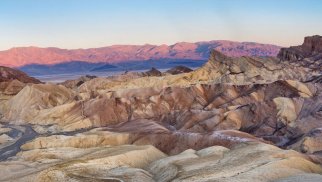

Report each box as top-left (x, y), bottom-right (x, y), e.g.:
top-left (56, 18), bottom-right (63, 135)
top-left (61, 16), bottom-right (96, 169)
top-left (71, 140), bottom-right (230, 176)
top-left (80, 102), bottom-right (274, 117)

top-left (21, 124), bottom-right (265, 155)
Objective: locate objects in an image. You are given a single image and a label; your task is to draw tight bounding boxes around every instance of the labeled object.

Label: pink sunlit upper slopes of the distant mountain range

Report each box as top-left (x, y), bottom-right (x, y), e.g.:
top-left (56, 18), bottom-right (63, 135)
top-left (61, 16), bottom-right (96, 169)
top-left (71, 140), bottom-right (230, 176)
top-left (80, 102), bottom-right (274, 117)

top-left (0, 40), bottom-right (281, 67)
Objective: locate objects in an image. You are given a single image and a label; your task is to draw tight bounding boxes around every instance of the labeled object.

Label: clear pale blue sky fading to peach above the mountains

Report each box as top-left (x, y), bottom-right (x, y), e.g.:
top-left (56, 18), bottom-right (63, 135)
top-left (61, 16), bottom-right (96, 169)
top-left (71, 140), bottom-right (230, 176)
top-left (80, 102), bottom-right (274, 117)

top-left (0, 0), bottom-right (322, 50)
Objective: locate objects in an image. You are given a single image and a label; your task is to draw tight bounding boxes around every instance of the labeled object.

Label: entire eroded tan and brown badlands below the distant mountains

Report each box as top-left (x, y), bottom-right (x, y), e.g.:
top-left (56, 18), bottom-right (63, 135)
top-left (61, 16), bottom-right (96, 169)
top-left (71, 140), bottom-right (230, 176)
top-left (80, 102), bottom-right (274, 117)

top-left (0, 36), bottom-right (322, 182)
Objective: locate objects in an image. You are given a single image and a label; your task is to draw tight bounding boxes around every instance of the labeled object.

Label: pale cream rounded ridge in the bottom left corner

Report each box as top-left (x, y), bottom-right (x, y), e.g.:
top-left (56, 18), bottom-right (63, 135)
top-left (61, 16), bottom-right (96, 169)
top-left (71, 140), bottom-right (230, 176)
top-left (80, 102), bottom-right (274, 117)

top-left (0, 145), bottom-right (166, 181)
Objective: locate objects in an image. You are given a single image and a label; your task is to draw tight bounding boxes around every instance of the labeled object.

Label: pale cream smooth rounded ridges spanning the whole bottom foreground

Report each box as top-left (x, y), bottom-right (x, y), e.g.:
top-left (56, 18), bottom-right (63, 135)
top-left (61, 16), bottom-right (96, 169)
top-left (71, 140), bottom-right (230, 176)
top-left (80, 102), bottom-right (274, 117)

top-left (0, 143), bottom-right (322, 182)
